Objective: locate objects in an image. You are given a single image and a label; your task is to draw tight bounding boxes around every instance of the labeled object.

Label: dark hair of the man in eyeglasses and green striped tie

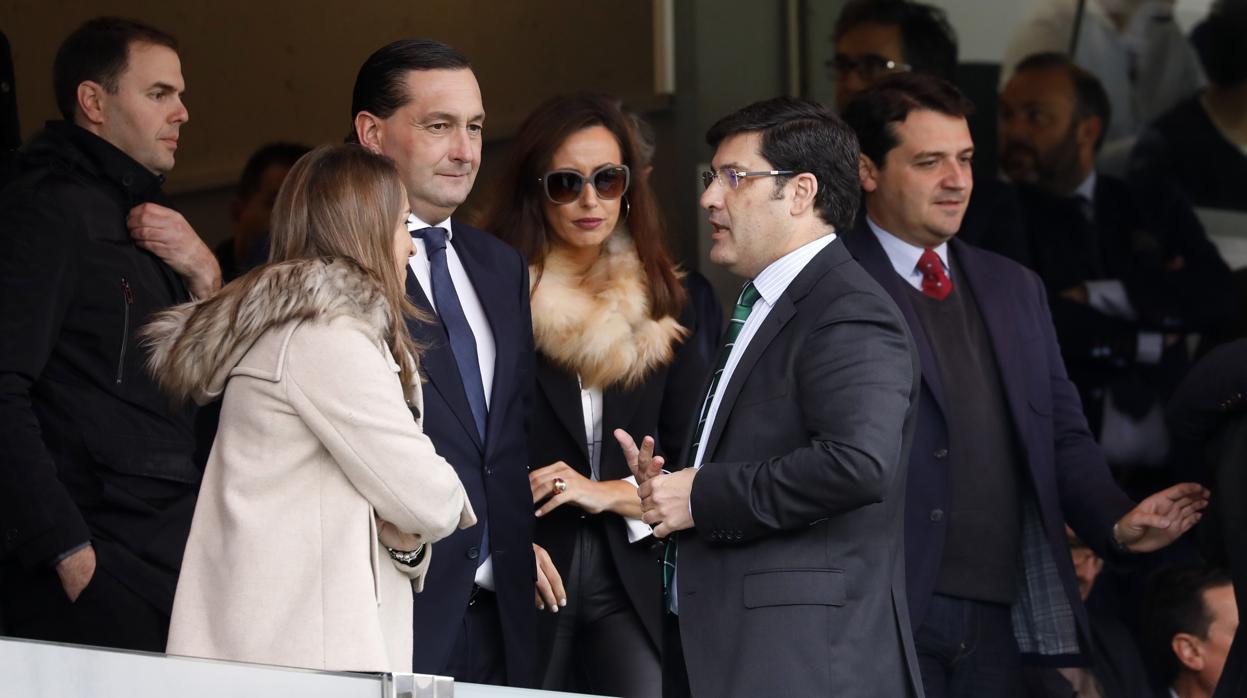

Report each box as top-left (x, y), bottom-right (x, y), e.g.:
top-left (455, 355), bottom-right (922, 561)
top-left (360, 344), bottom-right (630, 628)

top-left (706, 97), bottom-right (859, 232)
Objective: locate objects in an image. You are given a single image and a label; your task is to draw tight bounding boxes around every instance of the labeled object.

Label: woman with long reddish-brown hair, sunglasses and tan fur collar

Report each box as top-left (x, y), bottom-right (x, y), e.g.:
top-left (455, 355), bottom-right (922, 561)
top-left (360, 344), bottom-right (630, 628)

top-left (485, 95), bottom-right (706, 696)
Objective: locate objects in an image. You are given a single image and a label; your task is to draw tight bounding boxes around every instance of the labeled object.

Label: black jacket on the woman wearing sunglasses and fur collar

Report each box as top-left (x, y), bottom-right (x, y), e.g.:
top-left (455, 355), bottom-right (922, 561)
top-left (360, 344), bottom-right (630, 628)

top-left (529, 289), bottom-right (713, 651)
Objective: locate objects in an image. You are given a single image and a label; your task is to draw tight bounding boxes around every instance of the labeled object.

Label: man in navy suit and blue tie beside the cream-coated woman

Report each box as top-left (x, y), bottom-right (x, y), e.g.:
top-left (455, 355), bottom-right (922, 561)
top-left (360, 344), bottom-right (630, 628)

top-left (350, 40), bottom-right (553, 687)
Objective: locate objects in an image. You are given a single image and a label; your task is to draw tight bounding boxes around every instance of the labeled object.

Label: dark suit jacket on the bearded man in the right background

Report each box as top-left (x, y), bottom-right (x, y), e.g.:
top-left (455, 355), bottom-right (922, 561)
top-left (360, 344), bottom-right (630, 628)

top-left (1019, 175), bottom-right (1235, 433)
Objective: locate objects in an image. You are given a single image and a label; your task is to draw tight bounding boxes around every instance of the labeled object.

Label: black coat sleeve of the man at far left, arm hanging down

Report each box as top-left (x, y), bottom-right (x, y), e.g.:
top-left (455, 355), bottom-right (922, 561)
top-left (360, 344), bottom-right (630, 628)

top-left (0, 189), bottom-right (91, 567)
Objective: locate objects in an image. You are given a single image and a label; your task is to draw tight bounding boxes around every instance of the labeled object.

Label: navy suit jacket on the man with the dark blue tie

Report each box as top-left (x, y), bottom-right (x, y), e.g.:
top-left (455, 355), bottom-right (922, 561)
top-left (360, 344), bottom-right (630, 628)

top-left (408, 221), bottom-right (536, 686)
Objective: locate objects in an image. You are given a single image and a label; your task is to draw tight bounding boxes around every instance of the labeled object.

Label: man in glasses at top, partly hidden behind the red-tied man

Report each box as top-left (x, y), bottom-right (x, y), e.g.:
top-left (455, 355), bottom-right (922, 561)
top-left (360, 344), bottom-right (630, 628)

top-left (827, 0), bottom-right (1030, 264)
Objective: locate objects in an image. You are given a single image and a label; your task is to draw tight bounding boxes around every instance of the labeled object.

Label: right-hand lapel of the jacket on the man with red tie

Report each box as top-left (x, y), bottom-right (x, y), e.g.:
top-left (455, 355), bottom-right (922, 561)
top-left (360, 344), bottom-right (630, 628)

top-left (952, 241), bottom-right (1038, 436)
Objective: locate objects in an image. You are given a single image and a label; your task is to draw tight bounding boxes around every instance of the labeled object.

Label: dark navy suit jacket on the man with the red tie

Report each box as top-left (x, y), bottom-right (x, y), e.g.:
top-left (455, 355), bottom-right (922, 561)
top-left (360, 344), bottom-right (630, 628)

top-left (845, 219), bottom-right (1134, 656)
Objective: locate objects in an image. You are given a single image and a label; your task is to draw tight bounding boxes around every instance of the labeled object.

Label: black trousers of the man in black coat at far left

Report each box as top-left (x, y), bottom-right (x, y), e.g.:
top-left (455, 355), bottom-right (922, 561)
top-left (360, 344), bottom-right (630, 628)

top-left (0, 550), bottom-right (168, 652)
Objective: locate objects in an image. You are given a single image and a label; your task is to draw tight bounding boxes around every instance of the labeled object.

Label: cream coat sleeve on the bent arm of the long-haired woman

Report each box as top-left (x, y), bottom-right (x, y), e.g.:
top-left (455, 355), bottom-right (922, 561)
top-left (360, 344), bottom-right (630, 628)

top-left (283, 318), bottom-right (476, 542)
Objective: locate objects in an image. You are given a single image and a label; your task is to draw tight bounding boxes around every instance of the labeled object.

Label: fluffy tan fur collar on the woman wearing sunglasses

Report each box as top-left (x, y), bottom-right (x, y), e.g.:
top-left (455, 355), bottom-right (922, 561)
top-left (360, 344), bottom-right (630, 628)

top-left (530, 232), bottom-right (688, 388)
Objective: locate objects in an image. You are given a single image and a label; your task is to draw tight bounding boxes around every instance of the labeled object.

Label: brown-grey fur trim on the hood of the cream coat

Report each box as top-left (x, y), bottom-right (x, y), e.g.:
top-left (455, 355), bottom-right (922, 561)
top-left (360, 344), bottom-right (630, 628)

top-left (141, 258), bottom-right (389, 404)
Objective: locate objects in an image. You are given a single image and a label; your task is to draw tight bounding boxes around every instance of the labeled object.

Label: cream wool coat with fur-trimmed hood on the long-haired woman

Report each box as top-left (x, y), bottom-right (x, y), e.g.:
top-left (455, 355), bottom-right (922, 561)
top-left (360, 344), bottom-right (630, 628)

top-left (146, 259), bottom-right (476, 672)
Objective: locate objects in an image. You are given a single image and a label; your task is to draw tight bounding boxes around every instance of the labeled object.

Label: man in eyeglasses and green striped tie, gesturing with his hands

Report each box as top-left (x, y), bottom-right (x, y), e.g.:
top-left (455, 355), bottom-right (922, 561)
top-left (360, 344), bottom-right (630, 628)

top-left (616, 97), bottom-right (919, 697)
